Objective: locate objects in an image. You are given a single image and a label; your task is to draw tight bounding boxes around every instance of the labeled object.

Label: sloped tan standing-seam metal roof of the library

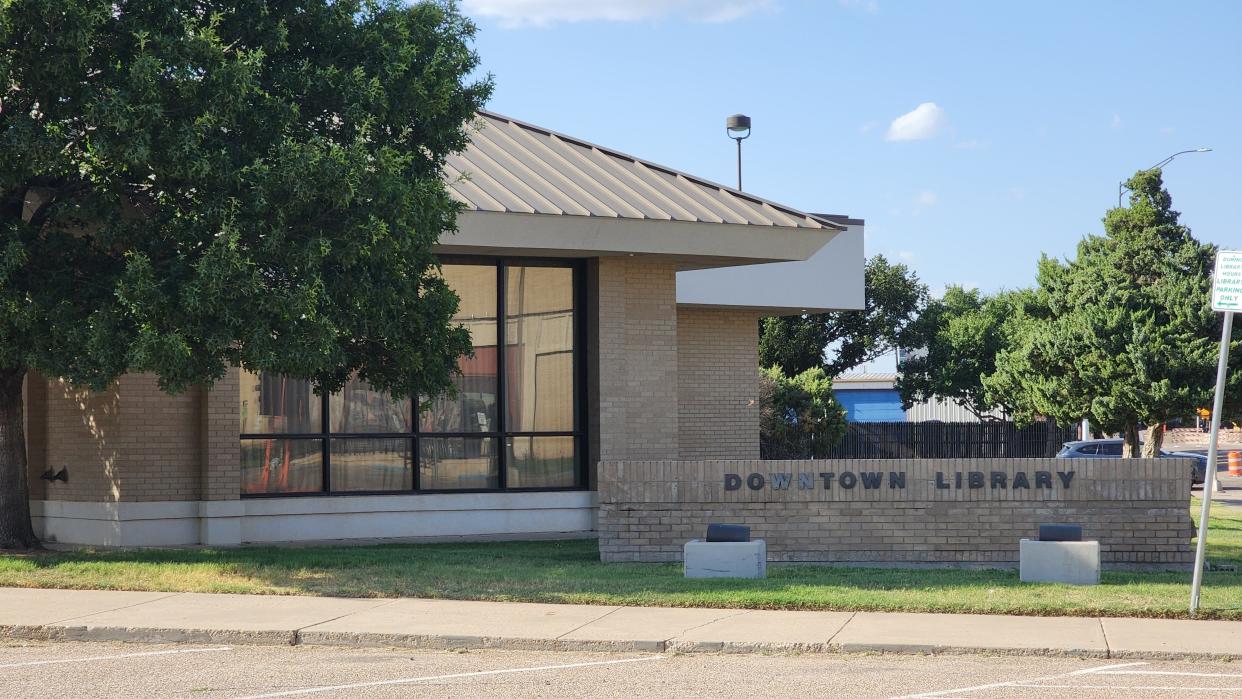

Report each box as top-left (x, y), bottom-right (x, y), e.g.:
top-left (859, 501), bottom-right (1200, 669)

top-left (445, 112), bottom-right (845, 230)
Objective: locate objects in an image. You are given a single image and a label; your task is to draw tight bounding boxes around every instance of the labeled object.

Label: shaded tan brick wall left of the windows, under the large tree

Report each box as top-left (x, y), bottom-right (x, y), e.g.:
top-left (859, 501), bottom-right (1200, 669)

top-left (27, 372), bottom-right (240, 502)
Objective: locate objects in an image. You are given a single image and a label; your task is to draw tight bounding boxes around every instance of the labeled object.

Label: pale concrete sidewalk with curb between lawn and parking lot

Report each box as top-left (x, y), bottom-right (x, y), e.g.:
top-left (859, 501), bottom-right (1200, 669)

top-left (0, 587), bottom-right (1242, 659)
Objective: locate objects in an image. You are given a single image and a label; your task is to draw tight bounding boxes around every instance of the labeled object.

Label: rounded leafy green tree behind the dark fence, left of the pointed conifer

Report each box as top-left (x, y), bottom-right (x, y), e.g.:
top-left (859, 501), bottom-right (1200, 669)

top-left (897, 287), bottom-right (1035, 418)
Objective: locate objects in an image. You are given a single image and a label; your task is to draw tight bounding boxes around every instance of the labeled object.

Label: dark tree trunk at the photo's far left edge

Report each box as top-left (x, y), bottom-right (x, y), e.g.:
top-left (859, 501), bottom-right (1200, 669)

top-left (0, 369), bottom-right (39, 550)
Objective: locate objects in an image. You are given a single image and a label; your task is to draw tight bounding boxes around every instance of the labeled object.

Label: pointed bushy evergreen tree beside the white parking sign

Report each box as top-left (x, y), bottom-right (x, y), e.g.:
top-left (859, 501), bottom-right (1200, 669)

top-left (984, 170), bottom-right (1221, 456)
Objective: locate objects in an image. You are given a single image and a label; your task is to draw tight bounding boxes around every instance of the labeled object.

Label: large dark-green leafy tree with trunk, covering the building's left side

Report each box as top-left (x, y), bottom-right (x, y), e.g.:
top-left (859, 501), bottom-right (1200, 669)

top-left (0, 0), bottom-right (491, 548)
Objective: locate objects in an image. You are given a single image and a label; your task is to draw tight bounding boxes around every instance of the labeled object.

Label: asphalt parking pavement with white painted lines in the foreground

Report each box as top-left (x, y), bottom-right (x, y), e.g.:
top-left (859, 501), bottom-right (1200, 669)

top-left (7, 641), bottom-right (1242, 699)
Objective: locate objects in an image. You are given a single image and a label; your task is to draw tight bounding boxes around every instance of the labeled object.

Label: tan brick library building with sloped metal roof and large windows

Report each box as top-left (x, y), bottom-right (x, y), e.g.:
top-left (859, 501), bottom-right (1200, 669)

top-left (25, 113), bottom-right (863, 546)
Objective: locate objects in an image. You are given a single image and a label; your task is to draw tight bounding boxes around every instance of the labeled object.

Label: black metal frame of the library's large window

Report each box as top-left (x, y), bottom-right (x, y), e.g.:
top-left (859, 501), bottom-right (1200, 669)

top-left (238, 255), bottom-right (590, 499)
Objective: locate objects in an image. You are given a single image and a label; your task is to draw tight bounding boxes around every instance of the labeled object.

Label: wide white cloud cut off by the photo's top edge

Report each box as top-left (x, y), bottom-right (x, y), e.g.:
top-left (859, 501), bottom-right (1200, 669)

top-left (462, 0), bottom-right (776, 29)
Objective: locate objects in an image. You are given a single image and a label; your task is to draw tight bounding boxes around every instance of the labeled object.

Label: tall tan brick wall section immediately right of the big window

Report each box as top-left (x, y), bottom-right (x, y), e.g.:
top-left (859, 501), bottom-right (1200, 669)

top-left (587, 257), bottom-right (678, 459)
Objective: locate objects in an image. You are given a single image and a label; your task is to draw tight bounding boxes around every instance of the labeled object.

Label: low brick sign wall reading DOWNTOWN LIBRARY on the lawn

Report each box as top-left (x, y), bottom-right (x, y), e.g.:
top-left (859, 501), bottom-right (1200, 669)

top-left (599, 458), bottom-right (1192, 569)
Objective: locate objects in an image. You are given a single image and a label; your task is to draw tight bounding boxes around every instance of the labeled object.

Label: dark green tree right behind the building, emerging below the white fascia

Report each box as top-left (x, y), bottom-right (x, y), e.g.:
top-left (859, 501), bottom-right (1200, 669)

top-left (759, 255), bottom-right (928, 376)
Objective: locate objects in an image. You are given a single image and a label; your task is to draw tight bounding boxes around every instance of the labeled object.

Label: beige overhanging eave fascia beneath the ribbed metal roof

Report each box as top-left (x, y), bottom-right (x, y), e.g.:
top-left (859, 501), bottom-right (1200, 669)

top-left (436, 211), bottom-right (841, 269)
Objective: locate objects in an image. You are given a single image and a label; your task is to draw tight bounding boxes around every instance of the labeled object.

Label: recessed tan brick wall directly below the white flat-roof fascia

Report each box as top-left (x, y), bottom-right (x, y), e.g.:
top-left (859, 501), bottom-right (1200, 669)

top-left (677, 308), bottom-right (759, 459)
